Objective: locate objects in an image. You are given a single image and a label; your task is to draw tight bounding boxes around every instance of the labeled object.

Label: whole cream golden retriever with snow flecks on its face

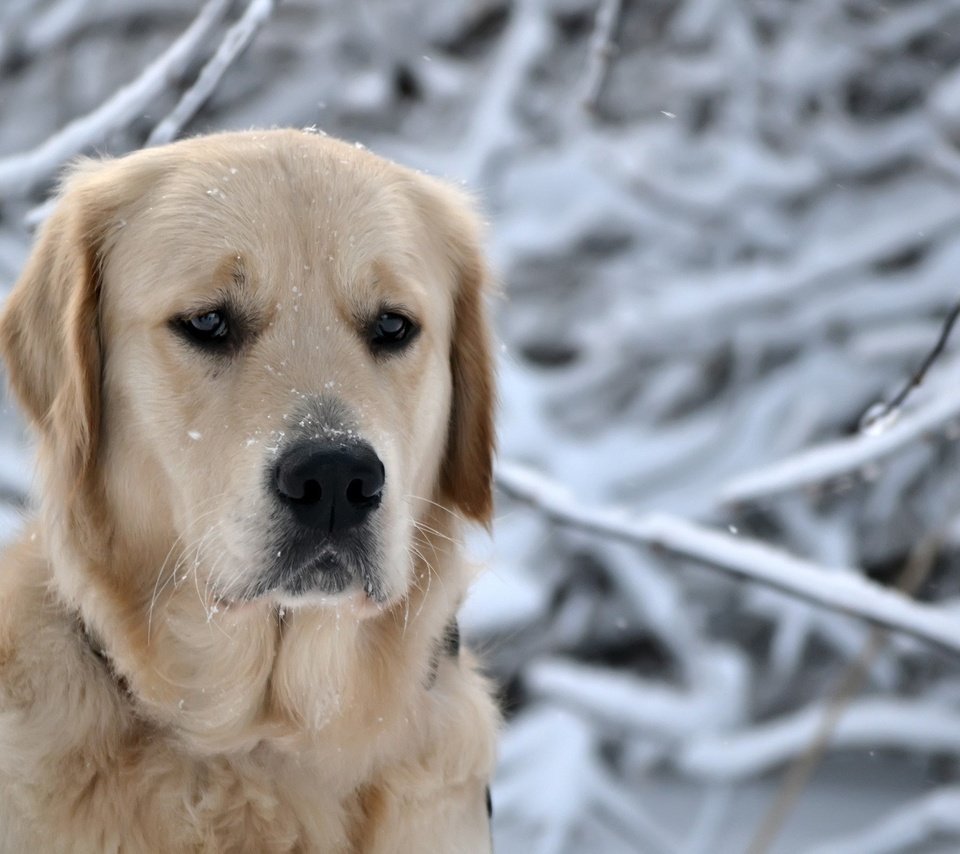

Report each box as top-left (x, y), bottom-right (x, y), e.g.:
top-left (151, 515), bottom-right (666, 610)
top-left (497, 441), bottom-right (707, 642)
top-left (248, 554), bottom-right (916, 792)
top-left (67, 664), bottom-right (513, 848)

top-left (0, 130), bottom-right (497, 854)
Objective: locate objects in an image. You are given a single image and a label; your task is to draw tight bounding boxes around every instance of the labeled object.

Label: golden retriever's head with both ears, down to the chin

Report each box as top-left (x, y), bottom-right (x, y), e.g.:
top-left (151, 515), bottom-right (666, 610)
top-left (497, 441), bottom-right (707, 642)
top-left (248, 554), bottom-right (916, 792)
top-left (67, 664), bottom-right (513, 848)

top-left (2, 131), bottom-right (492, 614)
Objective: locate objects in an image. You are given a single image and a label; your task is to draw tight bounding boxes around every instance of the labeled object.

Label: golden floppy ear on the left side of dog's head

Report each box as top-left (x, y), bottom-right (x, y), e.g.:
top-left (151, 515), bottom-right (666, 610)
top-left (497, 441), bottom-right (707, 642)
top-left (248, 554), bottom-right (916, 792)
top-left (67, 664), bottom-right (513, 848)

top-left (0, 168), bottom-right (109, 492)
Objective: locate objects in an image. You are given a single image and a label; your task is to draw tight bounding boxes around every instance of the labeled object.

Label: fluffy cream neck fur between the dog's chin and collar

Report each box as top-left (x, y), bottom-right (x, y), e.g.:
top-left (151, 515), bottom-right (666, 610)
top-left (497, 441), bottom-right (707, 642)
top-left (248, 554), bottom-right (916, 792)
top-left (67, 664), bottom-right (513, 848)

top-left (42, 482), bottom-right (468, 768)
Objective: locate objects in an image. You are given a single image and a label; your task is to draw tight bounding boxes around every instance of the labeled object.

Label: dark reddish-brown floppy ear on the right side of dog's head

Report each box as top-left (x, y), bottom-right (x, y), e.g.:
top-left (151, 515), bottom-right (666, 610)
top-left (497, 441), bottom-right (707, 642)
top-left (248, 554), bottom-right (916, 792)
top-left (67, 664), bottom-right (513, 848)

top-left (410, 179), bottom-right (496, 526)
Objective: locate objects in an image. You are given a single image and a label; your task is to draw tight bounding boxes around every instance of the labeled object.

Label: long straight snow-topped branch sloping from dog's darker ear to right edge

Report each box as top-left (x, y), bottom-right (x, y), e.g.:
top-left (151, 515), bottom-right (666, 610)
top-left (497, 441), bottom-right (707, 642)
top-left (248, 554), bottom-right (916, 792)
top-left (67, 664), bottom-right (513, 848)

top-left (497, 462), bottom-right (960, 653)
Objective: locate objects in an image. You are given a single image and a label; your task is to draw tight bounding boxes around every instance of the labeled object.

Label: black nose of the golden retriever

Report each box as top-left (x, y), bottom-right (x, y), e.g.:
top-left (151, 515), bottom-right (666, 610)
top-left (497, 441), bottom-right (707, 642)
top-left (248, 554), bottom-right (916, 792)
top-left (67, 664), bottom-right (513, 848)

top-left (275, 442), bottom-right (384, 534)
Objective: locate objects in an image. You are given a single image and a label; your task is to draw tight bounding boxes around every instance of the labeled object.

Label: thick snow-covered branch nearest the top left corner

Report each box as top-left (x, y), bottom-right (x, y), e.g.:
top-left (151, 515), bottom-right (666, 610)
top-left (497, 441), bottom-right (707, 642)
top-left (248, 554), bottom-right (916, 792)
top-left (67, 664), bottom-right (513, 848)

top-left (0, 0), bottom-right (231, 197)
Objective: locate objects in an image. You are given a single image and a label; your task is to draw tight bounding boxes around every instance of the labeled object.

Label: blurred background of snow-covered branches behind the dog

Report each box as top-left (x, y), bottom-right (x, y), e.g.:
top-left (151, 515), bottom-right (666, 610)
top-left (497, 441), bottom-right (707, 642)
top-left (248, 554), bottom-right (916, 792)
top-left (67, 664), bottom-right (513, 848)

top-left (0, 0), bottom-right (960, 854)
